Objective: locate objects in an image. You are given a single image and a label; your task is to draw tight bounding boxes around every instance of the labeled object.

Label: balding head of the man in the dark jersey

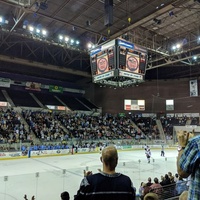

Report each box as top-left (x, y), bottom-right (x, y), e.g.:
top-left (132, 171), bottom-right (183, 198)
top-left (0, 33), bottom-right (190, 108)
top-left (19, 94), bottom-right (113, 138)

top-left (101, 146), bottom-right (118, 170)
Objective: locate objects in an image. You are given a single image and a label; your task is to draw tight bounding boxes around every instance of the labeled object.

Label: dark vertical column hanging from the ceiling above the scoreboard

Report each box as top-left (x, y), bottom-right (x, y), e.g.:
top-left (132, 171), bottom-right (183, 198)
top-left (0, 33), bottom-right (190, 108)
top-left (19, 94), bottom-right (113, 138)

top-left (104, 0), bottom-right (113, 26)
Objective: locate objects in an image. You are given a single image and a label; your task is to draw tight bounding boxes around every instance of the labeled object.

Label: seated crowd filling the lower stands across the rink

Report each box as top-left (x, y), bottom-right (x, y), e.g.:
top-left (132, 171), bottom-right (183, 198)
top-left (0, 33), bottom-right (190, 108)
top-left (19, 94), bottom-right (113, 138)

top-left (0, 109), bottom-right (199, 148)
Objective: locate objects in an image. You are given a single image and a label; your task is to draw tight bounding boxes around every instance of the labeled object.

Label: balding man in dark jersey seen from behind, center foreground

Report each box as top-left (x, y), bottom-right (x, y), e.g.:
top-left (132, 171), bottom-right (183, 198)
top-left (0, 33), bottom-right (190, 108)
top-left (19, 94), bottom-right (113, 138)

top-left (74, 146), bottom-right (135, 200)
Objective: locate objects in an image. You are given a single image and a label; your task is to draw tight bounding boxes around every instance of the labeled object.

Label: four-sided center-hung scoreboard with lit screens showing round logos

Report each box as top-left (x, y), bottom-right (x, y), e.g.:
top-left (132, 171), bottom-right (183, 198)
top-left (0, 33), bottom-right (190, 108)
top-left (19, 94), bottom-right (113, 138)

top-left (90, 39), bottom-right (147, 87)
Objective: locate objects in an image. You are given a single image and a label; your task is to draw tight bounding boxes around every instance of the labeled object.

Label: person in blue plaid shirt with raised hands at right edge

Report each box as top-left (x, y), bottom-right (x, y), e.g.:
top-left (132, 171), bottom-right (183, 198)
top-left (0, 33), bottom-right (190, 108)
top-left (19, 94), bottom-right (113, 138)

top-left (177, 131), bottom-right (200, 200)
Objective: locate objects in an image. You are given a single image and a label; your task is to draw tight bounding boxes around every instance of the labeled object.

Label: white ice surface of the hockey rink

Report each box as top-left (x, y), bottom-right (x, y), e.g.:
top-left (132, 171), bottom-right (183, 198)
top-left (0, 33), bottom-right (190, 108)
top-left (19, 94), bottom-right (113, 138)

top-left (0, 148), bottom-right (178, 200)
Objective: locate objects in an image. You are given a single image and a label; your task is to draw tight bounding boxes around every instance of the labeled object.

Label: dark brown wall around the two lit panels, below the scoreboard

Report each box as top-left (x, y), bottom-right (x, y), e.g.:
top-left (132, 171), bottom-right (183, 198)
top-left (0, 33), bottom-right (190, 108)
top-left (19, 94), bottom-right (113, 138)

top-left (86, 78), bottom-right (200, 114)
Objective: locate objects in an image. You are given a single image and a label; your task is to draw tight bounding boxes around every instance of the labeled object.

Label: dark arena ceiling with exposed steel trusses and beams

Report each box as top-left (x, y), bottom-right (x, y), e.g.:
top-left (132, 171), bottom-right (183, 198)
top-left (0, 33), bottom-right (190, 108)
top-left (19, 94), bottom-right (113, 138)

top-left (0, 0), bottom-right (200, 83)
